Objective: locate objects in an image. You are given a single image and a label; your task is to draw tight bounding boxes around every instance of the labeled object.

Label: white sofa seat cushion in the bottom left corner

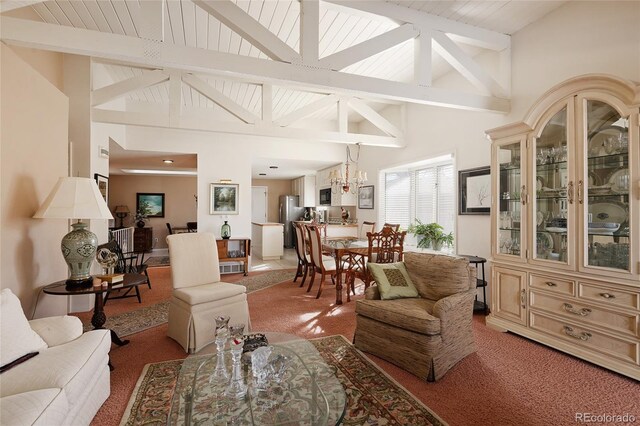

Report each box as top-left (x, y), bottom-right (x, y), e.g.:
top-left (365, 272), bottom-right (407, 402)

top-left (0, 388), bottom-right (69, 426)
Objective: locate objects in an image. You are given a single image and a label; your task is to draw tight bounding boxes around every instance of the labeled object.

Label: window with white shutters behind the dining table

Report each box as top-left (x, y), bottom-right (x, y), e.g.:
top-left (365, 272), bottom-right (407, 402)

top-left (381, 156), bottom-right (456, 240)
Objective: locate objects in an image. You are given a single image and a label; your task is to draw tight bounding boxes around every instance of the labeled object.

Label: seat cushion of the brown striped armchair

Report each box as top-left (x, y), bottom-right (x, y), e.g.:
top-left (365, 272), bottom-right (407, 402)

top-left (356, 298), bottom-right (440, 335)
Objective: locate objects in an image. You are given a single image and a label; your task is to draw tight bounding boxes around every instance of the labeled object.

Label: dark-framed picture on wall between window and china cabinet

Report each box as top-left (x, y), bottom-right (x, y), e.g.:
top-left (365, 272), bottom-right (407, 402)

top-left (458, 166), bottom-right (491, 215)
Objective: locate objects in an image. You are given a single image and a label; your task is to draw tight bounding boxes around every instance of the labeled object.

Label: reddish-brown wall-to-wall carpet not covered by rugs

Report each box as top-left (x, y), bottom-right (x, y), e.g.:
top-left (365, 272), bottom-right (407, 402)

top-left (89, 268), bottom-right (640, 426)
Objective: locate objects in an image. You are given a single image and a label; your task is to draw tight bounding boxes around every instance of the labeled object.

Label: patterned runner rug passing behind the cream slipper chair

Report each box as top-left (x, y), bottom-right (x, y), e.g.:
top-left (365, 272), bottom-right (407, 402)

top-left (83, 269), bottom-right (295, 337)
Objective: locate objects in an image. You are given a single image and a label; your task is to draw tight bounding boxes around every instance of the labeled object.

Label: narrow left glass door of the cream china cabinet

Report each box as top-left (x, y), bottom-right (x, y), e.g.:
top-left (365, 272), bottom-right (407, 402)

top-left (495, 140), bottom-right (525, 257)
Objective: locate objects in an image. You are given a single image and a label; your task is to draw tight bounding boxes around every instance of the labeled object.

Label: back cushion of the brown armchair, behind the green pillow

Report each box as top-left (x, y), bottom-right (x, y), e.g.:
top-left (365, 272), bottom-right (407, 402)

top-left (404, 252), bottom-right (471, 300)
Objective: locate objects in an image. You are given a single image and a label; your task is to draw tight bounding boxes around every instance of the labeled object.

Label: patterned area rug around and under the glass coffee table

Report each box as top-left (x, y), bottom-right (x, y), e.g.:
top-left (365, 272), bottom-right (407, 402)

top-left (121, 336), bottom-right (443, 426)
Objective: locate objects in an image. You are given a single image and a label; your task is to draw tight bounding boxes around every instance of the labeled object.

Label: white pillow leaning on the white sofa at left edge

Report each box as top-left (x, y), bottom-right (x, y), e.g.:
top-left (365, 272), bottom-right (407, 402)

top-left (0, 288), bottom-right (47, 365)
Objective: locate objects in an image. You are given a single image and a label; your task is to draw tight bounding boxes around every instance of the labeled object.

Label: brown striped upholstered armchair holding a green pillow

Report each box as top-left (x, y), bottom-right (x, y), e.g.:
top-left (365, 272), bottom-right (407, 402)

top-left (354, 252), bottom-right (476, 381)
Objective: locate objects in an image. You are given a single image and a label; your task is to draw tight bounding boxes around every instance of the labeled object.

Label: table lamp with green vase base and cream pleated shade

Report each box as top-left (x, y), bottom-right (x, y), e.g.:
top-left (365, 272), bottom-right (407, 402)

top-left (33, 177), bottom-right (113, 286)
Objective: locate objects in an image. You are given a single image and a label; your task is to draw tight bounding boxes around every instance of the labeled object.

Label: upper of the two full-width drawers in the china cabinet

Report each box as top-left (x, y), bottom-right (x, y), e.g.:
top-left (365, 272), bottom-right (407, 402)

top-left (529, 290), bottom-right (638, 337)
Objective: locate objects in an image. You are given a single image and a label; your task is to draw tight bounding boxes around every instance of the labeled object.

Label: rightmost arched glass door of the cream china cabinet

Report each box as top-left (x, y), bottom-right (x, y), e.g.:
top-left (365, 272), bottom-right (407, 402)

top-left (578, 100), bottom-right (631, 271)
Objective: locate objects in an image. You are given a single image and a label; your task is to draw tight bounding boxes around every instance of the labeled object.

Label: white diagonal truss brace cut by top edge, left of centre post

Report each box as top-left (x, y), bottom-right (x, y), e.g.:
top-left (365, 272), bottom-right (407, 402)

top-left (194, 0), bottom-right (300, 62)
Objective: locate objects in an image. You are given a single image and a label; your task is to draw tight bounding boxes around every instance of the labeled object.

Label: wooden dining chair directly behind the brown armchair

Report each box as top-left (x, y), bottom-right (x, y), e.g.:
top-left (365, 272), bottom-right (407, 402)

top-left (345, 226), bottom-right (407, 302)
